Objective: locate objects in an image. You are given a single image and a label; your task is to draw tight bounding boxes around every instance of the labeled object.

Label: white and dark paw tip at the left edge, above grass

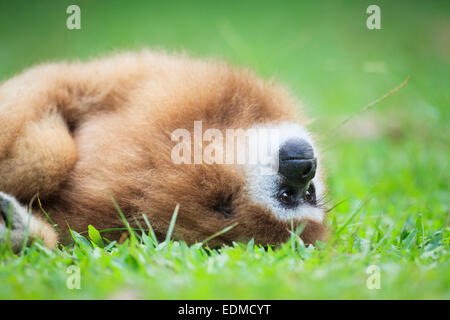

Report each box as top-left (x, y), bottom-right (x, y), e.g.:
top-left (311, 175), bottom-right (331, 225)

top-left (0, 192), bottom-right (28, 252)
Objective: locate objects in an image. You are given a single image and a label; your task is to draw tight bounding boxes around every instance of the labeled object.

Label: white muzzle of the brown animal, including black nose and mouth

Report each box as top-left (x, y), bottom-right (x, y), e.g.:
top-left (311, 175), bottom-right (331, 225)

top-left (246, 122), bottom-right (324, 223)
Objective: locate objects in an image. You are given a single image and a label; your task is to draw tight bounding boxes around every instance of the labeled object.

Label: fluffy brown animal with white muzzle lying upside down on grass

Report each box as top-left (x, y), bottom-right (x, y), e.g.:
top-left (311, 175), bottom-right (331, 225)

top-left (0, 51), bottom-right (326, 251)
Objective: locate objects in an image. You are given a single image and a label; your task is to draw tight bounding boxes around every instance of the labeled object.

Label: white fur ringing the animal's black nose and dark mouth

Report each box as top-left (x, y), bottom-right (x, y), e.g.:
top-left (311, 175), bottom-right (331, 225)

top-left (246, 122), bottom-right (324, 222)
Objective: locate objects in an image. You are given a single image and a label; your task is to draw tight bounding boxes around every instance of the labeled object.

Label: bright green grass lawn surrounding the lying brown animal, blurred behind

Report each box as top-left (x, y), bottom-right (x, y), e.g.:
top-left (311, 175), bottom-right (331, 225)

top-left (0, 1), bottom-right (450, 299)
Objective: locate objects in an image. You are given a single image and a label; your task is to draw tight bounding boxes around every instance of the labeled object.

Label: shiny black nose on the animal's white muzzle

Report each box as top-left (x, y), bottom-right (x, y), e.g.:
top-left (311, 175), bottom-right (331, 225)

top-left (278, 139), bottom-right (317, 185)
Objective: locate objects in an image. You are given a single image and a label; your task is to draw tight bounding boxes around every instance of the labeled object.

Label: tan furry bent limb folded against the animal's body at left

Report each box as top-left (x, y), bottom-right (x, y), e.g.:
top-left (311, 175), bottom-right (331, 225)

top-left (0, 52), bottom-right (154, 202)
